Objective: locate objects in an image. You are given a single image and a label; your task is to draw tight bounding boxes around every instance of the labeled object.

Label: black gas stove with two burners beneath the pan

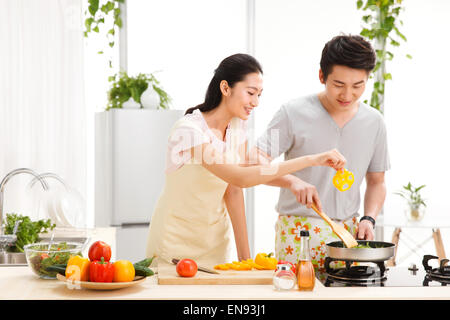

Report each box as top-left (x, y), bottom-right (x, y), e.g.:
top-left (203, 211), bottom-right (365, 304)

top-left (316, 255), bottom-right (450, 287)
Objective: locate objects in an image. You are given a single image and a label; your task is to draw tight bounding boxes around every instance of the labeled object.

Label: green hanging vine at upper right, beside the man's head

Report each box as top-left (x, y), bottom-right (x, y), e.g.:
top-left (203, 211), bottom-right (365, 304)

top-left (356, 0), bottom-right (412, 113)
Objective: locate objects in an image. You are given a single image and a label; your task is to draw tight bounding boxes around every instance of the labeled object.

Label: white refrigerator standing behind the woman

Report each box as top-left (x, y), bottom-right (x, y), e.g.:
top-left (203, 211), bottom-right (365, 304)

top-left (95, 109), bottom-right (184, 262)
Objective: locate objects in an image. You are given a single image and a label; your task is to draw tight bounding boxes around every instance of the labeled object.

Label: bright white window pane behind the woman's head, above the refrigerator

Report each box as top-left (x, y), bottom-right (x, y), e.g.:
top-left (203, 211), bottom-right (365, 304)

top-left (127, 0), bottom-right (246, 109)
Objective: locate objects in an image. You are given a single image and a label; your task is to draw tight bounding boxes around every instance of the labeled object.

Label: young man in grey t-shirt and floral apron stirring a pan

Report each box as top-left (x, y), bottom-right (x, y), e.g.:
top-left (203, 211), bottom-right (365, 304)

top-left (252, 35), bottom-right (390, 268)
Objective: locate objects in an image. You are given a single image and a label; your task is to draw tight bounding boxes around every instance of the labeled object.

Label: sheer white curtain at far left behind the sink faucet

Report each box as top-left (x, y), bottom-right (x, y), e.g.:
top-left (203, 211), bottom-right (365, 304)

top-left (0, 0), bottom-right (87, 225)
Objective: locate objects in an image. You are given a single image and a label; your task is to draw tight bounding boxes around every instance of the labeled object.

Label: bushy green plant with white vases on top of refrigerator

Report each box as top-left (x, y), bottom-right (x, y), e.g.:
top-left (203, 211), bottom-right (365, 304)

top-left (106, 71), bottom-right (171, 110)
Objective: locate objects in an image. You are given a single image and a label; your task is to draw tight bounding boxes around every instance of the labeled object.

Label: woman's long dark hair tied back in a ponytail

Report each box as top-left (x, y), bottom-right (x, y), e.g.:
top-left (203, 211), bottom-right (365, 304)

top-left (185, 53), bottom-right (263, 115)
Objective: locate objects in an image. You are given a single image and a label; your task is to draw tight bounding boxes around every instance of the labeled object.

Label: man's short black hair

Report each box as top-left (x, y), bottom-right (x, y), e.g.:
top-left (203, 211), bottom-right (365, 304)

top-left (320, 35), bottom-right (376, 81)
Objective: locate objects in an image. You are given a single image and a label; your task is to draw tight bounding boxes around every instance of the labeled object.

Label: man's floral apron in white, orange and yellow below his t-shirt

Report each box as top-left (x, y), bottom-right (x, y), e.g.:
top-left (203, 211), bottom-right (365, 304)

top-left (275, 215), bottom-right (358, 270)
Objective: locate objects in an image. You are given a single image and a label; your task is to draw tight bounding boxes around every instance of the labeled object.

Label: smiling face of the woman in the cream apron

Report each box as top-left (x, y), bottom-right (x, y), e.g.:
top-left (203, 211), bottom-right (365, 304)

top-left (220, 72), bottom-right (263, 120)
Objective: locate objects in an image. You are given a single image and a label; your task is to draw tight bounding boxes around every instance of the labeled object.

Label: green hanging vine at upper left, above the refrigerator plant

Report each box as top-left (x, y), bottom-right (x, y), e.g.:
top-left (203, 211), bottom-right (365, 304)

top-left (84, 0), bottom-right (125, 68)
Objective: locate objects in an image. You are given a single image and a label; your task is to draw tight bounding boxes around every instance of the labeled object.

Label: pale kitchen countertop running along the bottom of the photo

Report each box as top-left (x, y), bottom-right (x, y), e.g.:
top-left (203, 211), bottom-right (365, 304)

top-left (0, 266), bottom-right (450, 300)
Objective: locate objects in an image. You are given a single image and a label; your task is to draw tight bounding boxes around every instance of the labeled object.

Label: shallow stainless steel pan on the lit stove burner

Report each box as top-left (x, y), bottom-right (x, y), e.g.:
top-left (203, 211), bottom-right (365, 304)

top-left (326, 240), bottom-right (395, 262)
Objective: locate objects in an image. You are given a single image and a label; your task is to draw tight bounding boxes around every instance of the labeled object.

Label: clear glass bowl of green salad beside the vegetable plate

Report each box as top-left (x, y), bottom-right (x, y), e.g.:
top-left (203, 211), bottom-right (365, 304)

top-left (24, 242), bottom-right (83, 279)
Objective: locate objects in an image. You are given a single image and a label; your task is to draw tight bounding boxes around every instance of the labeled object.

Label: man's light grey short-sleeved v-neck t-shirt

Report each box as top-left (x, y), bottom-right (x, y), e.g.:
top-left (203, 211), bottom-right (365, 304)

top-left (256, 94), bottom-right (390, 220)
